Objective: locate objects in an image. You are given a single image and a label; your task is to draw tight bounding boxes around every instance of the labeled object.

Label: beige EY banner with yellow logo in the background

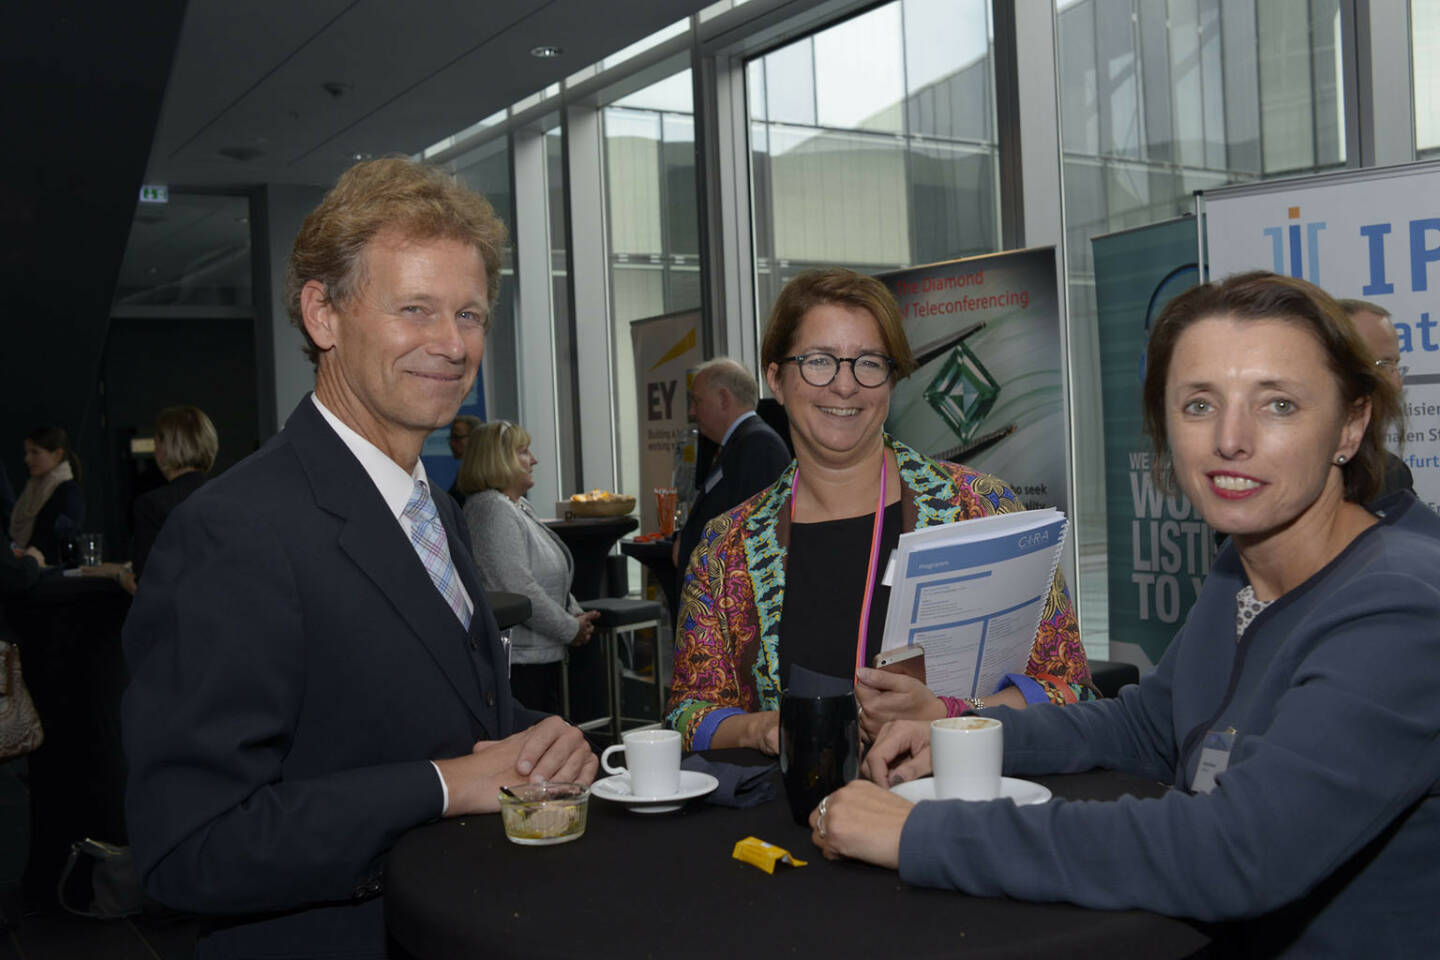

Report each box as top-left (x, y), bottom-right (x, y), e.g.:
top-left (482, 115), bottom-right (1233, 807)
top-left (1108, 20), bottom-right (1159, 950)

top-left (625, 309), bottom-right (701, 533)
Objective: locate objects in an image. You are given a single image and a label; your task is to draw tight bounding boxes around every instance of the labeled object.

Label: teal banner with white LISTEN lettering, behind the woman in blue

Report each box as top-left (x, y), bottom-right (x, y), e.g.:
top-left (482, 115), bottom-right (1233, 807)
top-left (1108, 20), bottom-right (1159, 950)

top-left (1092, 217), bottom-right (1214, 671)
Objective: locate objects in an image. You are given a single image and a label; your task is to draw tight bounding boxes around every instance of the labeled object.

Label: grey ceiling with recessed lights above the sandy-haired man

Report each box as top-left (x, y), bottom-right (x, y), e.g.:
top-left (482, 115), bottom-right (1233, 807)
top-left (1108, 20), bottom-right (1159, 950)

top-left (145, 0), bottom-right (710, 187)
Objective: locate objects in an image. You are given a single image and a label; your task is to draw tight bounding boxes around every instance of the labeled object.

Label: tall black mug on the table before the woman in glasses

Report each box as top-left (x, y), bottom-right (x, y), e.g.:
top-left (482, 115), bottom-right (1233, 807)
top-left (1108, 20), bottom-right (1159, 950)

top-left (780, 691), bottom-right (860, 826)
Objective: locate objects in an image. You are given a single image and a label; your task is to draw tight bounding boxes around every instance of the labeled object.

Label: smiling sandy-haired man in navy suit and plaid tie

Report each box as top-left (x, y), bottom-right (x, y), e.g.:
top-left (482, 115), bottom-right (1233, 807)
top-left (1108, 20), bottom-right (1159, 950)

top-left (124, 157), bottom-right (596, 959)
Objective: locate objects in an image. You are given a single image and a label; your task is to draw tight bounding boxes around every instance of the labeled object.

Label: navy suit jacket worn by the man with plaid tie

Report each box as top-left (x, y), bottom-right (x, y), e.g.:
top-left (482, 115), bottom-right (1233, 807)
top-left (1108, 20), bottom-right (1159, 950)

top-left (124, 397), bottom-right (543, 957)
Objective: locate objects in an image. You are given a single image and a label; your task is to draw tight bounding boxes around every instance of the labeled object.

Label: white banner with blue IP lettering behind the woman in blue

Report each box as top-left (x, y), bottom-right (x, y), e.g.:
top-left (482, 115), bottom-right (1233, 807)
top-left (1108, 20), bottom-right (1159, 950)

top-left (1202, 161), bottom-right (1440, 510)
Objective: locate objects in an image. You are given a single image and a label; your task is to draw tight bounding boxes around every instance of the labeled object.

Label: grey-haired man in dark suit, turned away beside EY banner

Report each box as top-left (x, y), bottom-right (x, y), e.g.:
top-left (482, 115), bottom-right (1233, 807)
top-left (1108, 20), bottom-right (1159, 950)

top-left (672, 357), bottom-right (791, 583)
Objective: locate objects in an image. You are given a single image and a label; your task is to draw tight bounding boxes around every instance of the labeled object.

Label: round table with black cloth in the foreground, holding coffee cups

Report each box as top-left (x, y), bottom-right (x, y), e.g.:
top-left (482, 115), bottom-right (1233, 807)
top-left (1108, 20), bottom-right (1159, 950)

top-left (386, 751), bottom-right (1207, 960)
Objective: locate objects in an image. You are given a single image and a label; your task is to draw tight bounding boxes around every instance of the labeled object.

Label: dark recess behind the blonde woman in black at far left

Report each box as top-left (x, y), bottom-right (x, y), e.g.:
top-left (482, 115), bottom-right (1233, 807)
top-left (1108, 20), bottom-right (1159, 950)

top-left (100, 317), bottom-right (259, 558)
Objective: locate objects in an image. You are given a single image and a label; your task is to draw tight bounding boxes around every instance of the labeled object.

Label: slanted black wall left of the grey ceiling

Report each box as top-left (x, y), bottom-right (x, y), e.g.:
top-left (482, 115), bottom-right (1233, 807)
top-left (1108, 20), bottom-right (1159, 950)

top-left (0, 0), bottom-right (190, 526)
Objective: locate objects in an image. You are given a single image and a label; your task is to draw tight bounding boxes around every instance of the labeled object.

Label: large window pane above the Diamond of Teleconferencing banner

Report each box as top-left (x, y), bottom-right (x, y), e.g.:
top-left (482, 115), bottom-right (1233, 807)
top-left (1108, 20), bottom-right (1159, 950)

top-left (747, 0), bottom-right (999, 317)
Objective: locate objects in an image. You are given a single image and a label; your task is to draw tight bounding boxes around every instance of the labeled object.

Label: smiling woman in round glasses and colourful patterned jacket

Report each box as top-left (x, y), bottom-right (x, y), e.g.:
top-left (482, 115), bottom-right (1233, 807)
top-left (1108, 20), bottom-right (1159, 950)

top-left (668, 268), bottom-right (1096, 754)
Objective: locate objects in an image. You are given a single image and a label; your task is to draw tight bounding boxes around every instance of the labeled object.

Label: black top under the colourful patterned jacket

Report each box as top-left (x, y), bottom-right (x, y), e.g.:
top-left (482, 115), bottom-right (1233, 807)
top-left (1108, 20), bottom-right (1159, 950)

top-left (779, 501), bottom-right (900, 687)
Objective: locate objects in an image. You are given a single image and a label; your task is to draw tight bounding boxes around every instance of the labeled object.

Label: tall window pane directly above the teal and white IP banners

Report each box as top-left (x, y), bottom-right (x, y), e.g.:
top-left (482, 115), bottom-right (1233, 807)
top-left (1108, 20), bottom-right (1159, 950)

top-left (1057, 0), bottom-right (1345, 643)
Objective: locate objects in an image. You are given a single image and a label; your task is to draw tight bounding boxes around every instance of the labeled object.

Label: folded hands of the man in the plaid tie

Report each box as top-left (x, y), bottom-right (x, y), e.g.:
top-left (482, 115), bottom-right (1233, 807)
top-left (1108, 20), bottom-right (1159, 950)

top-left (435, 717), bottom-right (599, 816)
